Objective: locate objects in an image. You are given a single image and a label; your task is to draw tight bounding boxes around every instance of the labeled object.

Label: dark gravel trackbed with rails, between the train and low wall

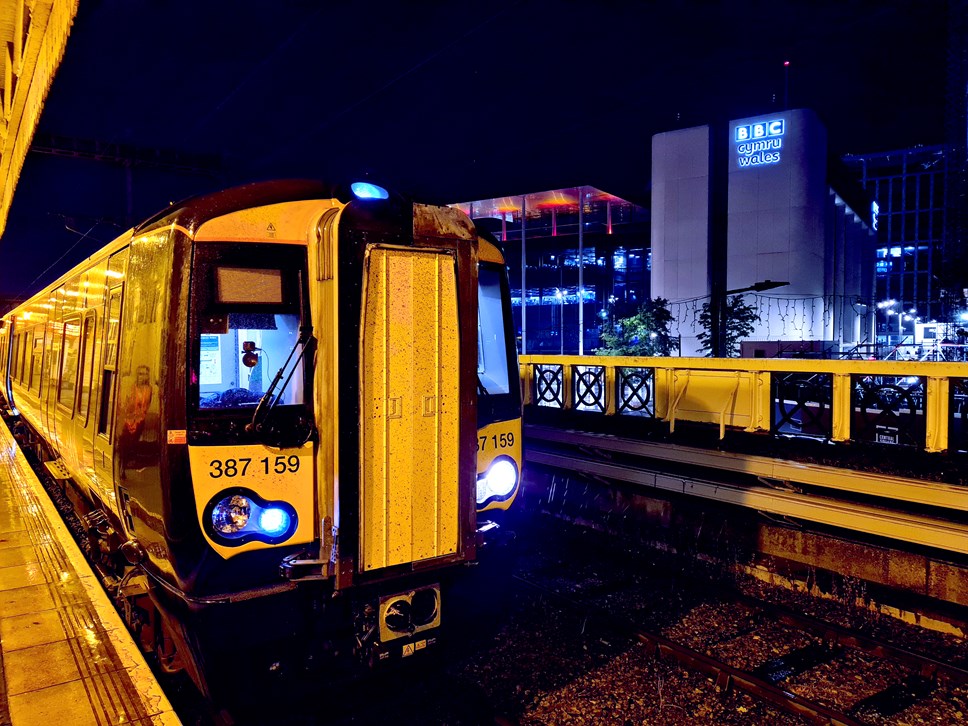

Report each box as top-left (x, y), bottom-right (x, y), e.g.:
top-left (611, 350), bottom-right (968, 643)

top-left (11, 398), bottom-right (968, 726)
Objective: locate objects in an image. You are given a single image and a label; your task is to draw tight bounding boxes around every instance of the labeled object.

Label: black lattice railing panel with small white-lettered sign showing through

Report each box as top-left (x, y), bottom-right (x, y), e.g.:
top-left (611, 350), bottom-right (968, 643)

top-left (851, 375), bottom-right (925, 447)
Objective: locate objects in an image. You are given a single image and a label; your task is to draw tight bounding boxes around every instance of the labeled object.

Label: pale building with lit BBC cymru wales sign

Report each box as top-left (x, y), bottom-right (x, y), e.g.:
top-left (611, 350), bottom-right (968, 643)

top-left (652, 110), bottom-right (873, 357)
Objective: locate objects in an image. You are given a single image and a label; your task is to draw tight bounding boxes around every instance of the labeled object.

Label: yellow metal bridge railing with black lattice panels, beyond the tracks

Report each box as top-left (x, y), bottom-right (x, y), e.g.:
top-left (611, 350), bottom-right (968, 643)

top-left (520, 356), bottom-right (968, 452)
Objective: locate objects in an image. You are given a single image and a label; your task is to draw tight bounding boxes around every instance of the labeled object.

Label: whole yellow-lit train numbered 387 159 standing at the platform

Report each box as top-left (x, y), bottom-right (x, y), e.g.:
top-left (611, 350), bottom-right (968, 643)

top-left (0, 183), bottom-right (521, 690)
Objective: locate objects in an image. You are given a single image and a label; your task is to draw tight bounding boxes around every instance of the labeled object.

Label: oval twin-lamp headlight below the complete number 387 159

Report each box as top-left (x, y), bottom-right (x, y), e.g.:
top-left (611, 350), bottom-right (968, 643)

top-left (202, 487), bottom-right (298, 547)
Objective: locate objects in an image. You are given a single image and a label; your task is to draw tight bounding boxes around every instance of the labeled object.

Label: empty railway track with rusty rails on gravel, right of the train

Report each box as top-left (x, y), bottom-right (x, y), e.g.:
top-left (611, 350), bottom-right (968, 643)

top-left (506, 520), bottom-right (968, 725)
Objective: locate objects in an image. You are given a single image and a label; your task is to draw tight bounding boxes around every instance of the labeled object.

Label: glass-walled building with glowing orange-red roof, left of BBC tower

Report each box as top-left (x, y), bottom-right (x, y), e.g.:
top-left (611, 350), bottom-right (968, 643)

top-left (454, 186), bottom-right (651, 355)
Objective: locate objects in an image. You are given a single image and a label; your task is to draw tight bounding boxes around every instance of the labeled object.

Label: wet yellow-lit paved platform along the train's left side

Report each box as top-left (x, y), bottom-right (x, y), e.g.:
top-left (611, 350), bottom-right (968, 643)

top-left (0, 425), bottom-right (181, 726)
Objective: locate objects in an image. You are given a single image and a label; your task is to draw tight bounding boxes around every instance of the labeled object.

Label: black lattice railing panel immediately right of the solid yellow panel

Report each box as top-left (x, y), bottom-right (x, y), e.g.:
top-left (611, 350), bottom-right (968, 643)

top-left (770, 373), bottom-right (833, 439)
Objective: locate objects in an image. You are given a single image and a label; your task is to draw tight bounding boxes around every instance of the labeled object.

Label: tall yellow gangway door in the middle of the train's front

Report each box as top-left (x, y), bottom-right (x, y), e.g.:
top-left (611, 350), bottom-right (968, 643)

top-left (358, 246), bottom-right (462, 573)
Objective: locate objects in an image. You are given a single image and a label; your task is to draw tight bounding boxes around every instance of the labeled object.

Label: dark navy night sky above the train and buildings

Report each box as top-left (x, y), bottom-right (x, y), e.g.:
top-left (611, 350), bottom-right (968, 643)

top-left (0, 0), bottom-right (948, 298)
